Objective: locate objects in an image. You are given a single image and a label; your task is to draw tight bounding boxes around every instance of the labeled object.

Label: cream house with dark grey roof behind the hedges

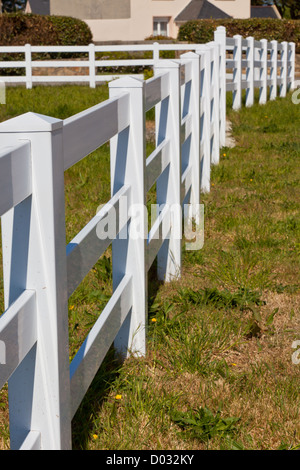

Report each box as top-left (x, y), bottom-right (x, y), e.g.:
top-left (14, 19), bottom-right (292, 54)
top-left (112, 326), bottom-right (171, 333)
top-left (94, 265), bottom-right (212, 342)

top-left (25, 0), bottom-right (280, 43)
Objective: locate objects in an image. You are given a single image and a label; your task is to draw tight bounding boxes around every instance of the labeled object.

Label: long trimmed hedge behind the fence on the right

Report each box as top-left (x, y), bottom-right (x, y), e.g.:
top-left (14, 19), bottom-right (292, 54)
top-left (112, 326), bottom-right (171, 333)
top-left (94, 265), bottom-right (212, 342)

top-left (178, 18), bottom-right (300, 53)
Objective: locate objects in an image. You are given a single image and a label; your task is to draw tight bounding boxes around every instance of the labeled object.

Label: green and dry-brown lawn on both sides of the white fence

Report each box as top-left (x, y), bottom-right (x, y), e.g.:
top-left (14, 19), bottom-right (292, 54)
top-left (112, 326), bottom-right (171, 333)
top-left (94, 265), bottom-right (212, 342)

top-left (0, 86), bottom-right (300, 450)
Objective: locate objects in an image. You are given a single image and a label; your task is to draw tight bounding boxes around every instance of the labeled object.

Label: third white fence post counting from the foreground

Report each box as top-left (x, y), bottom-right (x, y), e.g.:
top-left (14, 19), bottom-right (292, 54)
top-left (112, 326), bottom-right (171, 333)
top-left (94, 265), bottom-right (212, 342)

top-left (154, 60), bottom-right (182, 282)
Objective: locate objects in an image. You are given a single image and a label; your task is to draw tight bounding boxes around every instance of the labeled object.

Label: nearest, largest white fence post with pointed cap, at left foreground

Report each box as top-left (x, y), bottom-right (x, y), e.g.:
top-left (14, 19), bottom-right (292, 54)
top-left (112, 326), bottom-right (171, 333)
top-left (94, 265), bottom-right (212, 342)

top-left (0, 113), bottom-right (71, 450)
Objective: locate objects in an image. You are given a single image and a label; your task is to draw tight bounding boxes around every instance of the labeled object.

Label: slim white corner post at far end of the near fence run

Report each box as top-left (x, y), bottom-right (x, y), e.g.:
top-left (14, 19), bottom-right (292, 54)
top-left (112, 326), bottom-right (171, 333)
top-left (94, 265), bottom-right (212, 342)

top-left (214, 26), bottom-right (226, 147)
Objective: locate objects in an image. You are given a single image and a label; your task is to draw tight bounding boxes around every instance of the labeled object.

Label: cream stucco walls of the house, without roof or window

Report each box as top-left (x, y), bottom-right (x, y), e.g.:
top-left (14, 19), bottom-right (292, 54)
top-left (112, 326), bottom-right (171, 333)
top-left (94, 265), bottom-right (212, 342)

top-left (51, 0), bottom-right (251, 42)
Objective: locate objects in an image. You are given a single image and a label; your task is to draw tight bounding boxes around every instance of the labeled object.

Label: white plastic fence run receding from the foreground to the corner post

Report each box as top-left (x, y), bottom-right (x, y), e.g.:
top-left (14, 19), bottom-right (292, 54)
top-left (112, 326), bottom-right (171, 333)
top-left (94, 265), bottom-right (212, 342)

top-left (0, 28), bottom-right (296, 449)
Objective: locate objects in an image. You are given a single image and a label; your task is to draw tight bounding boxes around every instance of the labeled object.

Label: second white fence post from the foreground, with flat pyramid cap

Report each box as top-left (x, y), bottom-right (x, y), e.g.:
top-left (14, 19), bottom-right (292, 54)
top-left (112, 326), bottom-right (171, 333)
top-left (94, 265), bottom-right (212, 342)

top-left (109, 77), bottom-right (148, 357)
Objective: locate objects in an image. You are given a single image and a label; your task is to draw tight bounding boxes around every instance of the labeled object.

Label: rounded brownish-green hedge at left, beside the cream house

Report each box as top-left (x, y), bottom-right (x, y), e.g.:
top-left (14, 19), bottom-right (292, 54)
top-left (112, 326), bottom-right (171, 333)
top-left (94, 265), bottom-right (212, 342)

top-left (0, 13), bottom-right (93, 46)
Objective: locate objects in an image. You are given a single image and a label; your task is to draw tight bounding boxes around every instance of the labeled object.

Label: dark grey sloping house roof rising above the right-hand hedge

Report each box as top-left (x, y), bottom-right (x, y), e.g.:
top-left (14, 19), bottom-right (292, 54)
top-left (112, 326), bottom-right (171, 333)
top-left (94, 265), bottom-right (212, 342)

top-left (175, 0), bottom-right (231, 22)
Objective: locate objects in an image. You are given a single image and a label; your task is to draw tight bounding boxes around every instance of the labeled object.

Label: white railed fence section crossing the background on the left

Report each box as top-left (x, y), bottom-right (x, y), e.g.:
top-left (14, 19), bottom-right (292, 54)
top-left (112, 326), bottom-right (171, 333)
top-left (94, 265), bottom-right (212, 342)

top-left (0, 43), bottom-right (210, 88)
